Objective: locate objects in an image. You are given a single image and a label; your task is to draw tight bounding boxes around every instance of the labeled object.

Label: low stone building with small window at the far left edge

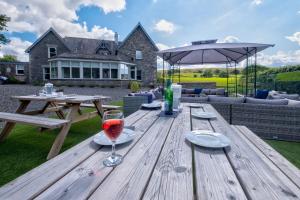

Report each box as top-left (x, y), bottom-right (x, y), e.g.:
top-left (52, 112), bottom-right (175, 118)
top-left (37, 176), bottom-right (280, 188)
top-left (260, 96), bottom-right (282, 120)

top-left (0, 61), bottom-right (29, 83)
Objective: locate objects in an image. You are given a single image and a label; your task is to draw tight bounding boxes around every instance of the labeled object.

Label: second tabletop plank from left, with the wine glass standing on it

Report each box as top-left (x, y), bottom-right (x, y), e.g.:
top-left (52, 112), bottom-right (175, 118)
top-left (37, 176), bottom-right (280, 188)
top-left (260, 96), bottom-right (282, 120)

top-left (36, 112), bottom-right (157, 200)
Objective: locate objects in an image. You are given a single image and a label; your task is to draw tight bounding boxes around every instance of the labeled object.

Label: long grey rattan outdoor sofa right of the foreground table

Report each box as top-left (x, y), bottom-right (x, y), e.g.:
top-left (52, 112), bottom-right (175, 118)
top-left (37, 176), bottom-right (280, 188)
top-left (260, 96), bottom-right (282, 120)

top-left (181, 95), bottom-right (300, 141)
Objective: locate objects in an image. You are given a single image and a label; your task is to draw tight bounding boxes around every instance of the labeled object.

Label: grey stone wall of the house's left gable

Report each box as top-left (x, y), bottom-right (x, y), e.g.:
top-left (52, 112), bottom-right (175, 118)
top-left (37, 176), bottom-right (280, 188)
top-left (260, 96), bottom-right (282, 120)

top-left (29, 31), bottom-right (69, 83)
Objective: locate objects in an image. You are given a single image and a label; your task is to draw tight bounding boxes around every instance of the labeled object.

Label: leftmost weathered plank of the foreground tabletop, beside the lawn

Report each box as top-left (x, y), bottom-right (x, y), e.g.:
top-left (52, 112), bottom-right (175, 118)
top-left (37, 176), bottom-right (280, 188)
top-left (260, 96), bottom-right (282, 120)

top-left (0, 110), bottom-right (149, 200)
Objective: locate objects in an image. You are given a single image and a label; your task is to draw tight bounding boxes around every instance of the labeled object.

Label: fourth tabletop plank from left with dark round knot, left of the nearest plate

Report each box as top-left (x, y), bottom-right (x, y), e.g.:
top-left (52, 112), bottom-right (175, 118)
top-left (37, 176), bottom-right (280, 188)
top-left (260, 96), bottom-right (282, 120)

top-left (143, 106), bottom-right (194, 200)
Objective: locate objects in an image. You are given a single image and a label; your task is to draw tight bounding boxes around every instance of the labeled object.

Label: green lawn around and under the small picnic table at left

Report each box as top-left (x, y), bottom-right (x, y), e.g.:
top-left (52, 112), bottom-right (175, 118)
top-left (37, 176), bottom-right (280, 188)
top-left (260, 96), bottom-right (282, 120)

top-left (0, 101), bottom-right (123, 186)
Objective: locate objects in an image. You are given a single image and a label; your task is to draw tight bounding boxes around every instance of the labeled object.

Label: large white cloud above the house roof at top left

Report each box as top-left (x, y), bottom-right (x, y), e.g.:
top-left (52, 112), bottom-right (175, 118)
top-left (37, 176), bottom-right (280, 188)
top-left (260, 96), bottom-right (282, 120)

top-left (0, 0), bottom-right (126, 39)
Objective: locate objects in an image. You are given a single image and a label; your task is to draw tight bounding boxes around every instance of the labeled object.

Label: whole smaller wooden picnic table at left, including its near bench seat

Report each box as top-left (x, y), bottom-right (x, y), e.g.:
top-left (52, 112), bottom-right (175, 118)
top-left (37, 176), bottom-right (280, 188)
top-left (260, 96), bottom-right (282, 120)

top-left (0, 95), bottom-right (110, 159)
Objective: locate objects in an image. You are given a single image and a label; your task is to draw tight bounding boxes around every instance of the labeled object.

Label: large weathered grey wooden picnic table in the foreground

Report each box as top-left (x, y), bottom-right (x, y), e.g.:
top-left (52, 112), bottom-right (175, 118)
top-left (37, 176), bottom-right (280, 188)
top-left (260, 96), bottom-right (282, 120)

top-left (0, 104), bottom-right (300, 200)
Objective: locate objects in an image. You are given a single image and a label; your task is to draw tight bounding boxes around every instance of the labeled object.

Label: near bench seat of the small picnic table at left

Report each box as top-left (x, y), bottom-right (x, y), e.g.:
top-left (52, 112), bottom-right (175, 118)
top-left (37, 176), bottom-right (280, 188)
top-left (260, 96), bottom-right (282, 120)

top-left (0, 112), bottom-right (69, 129)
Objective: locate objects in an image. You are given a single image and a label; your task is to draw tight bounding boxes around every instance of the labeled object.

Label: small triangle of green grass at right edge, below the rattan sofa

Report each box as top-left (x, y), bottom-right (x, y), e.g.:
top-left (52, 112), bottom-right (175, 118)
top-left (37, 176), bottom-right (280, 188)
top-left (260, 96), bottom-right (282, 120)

top-left (265, 140), bottom-right (300, 169)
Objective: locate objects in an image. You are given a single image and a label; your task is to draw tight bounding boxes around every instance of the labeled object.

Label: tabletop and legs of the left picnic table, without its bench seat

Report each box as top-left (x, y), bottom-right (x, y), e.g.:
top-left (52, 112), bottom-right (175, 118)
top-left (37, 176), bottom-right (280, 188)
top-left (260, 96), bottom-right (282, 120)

top-left (0, 95), bottom-right (110, 159)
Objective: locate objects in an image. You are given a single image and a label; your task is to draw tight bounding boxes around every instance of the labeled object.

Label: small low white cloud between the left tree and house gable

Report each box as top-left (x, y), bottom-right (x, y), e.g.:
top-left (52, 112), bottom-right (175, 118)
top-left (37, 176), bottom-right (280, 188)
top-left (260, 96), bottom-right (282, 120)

top-left (0, 37), bottom-right (32, 61)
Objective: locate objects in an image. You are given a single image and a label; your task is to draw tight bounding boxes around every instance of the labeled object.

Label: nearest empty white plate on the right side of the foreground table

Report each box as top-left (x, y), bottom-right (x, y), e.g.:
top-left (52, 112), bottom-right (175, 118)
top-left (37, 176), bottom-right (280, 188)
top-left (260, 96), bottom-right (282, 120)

top-left (185, 130), bottom-right (230, 148)
